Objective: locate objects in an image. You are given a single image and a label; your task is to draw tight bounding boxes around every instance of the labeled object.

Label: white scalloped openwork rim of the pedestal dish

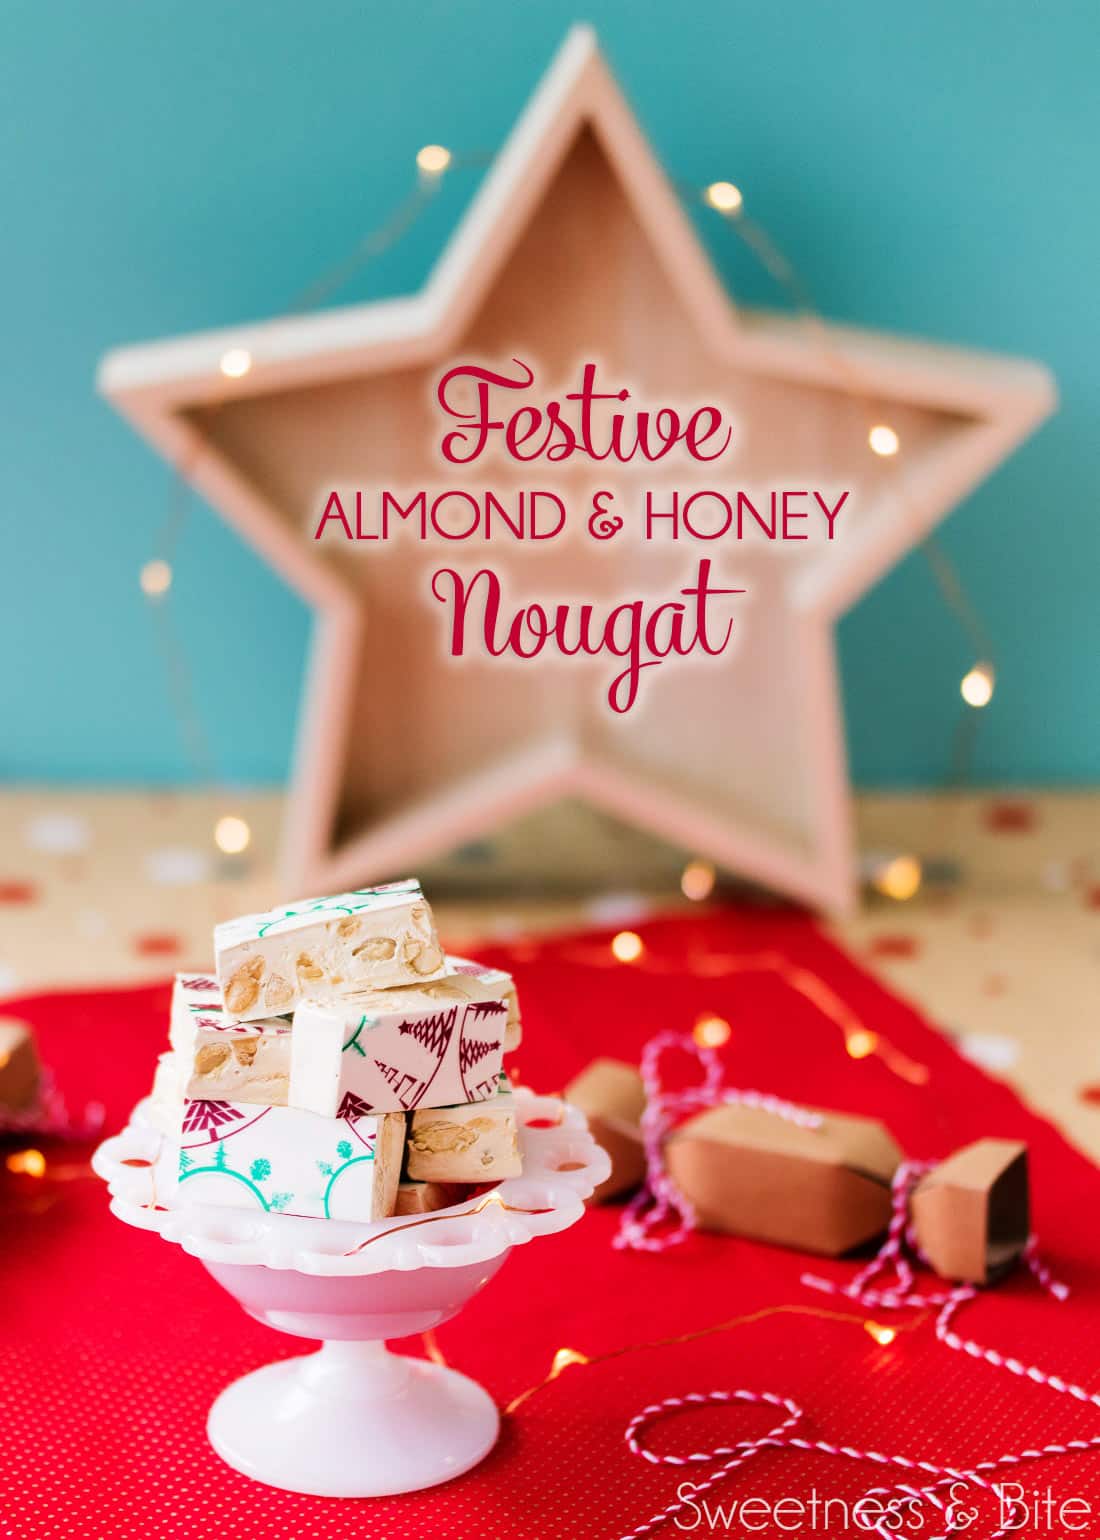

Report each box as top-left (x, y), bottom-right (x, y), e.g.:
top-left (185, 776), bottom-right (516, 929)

top-left (92, 1087), bottom-right (610, 1278)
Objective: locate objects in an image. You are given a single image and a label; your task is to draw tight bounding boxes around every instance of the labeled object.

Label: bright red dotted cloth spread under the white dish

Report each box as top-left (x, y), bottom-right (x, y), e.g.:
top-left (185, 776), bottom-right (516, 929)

top-left (0, 910), bottom-right (1100, 1540)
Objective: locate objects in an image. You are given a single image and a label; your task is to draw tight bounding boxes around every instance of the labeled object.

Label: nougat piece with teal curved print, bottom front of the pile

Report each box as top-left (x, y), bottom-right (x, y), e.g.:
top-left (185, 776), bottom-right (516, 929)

top-left (177, 1098), bottom-right (405, 1221)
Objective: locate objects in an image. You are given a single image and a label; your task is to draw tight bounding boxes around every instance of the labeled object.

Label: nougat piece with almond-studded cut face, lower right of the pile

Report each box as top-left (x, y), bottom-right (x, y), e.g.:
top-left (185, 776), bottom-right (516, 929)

top-left (405, 1078), bottom-right (524, 1183)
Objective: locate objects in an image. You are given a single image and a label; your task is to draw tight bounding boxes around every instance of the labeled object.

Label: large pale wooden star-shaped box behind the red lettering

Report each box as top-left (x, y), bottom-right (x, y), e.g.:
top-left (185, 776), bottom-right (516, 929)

top-left (100, 28), bottom-right (1054, 907)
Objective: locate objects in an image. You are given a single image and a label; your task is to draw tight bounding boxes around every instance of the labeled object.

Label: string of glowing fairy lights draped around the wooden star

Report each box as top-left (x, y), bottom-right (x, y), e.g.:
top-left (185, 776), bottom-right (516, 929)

top-left (139, 145), bottom-right (997, 901)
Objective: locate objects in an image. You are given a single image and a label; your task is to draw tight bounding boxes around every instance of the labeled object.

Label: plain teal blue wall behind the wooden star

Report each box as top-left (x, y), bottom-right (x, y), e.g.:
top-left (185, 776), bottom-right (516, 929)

top-left (0, 0), bottom-right (1100, 785)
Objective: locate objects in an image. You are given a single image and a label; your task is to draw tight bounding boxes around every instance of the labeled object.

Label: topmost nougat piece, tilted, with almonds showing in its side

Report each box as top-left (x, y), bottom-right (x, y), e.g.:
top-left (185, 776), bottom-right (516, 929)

top-left (214, 878), bottom-right (445, 1021)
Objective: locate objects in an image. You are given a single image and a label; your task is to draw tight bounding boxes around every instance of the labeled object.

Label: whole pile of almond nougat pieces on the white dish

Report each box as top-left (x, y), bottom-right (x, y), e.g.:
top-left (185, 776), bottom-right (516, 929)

top-left (148, 879), bottom-right (521, 1221)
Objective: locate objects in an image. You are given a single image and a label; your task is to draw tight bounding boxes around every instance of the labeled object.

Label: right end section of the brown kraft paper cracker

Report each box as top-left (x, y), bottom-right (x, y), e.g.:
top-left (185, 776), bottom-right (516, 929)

top-left (909, 1140), bottom-right (1031, 1283)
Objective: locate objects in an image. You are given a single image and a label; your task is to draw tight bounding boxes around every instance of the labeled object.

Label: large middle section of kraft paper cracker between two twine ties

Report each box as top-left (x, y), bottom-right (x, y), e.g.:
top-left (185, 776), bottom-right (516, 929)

top-left (664, 1103), bottom-right (901, 1257)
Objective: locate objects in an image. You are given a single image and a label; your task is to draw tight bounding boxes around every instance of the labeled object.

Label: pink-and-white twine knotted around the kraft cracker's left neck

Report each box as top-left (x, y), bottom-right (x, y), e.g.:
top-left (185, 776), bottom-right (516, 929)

top-left (613, 1032), bottom-right (821, 1252)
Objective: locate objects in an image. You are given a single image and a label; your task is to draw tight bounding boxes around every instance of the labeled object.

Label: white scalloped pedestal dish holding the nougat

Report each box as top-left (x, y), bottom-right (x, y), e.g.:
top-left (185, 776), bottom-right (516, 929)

top-left (92, 1092), bottom-right (610, 1497)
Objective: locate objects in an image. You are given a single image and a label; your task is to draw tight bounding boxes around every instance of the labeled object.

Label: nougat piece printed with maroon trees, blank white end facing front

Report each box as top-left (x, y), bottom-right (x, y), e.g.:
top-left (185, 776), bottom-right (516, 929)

top-left (288, 972), bottom-right (508, 1117)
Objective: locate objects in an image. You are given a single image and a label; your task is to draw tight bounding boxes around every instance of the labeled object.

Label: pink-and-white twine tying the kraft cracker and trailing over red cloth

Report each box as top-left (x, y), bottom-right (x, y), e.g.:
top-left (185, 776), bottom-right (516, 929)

top-left (616, 1032), bottom-right (1100, 1540)
